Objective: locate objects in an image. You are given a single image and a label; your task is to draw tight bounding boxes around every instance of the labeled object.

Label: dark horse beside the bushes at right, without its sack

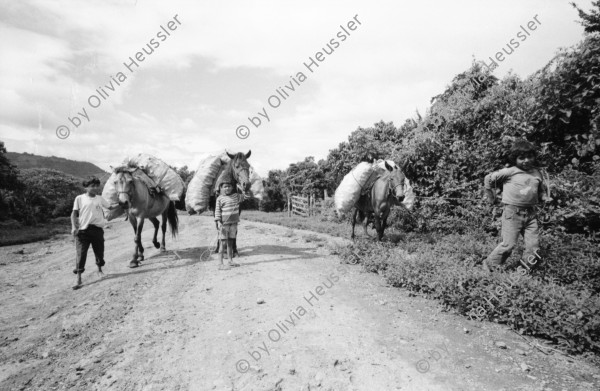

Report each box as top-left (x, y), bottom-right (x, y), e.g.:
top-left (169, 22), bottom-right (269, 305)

top-left (351, 161), bottom-right (406, 241)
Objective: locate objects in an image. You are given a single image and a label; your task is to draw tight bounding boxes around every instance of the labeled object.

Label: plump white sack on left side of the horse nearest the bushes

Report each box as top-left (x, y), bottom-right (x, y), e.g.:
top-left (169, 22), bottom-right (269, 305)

top-left (334, 162), bottom-right (385, 214)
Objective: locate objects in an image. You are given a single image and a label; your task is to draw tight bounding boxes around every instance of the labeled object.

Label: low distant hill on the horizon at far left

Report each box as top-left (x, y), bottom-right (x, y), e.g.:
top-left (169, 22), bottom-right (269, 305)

top-left (6, 152), bottom-right (106, 178)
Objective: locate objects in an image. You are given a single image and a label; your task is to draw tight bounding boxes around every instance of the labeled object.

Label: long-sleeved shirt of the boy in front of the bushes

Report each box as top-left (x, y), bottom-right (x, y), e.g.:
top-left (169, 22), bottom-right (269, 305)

top-left (484, 166), bottom-right (544, 207)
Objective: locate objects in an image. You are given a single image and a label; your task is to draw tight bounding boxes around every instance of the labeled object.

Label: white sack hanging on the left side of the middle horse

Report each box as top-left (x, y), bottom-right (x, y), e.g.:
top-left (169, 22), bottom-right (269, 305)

top-left (185, 155), bottom-right (227, 213)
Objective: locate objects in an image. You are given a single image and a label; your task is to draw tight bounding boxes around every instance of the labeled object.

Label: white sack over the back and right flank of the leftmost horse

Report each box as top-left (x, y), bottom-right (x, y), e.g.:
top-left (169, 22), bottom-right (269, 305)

top-left (123, 153), bottom-right (185, 201)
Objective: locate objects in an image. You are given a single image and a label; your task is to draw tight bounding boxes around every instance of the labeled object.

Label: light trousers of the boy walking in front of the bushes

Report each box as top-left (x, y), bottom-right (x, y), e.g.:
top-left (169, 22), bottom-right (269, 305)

top-left (487, 205), bottom-right (539, 266)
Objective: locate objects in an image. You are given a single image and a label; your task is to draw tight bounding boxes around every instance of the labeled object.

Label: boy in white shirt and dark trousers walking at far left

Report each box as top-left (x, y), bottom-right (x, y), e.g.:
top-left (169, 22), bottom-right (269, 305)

top-left (71, 177), bottom-right (118, 288)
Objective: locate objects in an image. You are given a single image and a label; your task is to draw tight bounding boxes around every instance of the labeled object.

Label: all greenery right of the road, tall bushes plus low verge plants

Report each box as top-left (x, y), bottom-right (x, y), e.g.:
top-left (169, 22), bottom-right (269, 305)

top-left (242, 1), bottom-right (600, 362)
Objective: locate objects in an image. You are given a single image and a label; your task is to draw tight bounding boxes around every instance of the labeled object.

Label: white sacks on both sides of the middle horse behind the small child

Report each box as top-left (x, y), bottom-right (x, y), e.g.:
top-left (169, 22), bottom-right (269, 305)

top-left (185, 152), bottom-right (264, 214)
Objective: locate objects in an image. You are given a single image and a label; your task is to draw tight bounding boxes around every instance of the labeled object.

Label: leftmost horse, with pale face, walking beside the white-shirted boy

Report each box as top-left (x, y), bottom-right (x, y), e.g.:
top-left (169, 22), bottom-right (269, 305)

top-left (115, 167), bottom-right (179, 268)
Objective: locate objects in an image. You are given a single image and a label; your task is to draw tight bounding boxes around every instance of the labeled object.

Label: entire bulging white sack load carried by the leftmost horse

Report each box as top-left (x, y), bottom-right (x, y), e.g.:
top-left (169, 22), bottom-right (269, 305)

top-left (102, 153), bottom-right (185, 221)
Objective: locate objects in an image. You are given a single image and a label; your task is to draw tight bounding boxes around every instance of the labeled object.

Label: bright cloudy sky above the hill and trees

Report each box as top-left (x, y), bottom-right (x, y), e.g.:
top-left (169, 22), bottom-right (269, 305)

top-left (0, 0), bottom-right (591, 175)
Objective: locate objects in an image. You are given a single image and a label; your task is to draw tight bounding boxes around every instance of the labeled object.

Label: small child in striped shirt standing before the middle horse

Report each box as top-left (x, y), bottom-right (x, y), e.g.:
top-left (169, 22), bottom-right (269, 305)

top-left (215, 182), bottom-right (247, 270)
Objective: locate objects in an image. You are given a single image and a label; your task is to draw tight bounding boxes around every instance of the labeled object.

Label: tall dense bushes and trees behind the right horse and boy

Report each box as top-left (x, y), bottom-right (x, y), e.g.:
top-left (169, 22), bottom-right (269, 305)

top-left (268, 18), bottom-right (600, 239)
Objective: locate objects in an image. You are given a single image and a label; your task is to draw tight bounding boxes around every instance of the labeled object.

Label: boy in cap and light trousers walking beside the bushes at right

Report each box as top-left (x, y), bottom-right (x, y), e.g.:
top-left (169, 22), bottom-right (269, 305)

top-left (483, 140), bottom-right (549, 271)
